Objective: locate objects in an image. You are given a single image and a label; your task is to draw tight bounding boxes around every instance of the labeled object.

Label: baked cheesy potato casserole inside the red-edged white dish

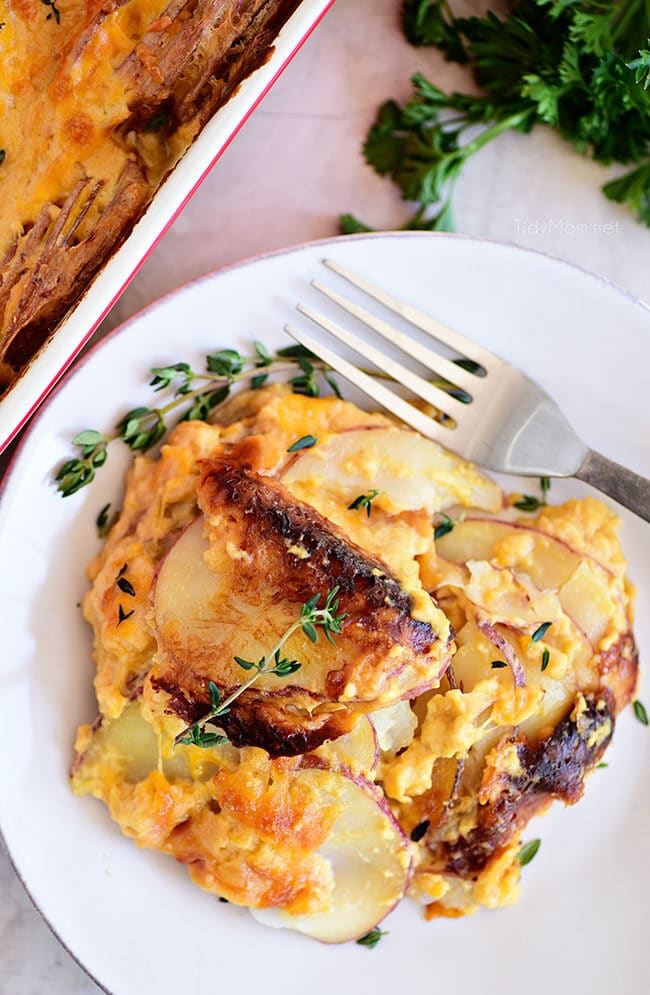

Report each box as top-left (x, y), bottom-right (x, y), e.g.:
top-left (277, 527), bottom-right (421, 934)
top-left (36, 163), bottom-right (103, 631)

top-left (0, 0), bottom-right (302, 396)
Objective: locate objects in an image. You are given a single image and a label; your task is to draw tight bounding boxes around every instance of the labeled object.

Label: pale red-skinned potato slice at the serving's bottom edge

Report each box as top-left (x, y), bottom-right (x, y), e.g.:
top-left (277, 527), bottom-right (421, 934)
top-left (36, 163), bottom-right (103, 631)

top-left (251, 770), bottom-right (412, 943)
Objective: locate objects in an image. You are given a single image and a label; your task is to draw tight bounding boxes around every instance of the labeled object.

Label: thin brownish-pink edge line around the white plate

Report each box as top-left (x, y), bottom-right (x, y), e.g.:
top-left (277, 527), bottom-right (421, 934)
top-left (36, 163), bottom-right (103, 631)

top-left (0, 231), bottom-right (650, 995)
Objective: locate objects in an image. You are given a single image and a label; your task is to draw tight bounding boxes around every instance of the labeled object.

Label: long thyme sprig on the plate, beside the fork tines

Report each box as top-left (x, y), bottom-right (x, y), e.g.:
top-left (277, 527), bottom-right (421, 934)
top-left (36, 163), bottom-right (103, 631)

top-left (55, 341), bottom-right (341, 497)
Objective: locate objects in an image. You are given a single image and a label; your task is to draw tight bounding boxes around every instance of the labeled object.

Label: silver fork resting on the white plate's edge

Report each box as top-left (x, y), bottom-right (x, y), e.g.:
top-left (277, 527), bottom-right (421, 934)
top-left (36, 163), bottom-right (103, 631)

top-left (286, 259), bottom-right (650, 522)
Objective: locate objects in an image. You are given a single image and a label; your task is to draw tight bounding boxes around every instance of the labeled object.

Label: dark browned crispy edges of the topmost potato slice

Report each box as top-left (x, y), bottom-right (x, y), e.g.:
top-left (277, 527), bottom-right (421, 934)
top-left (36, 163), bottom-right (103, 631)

top-left (152, 458), bottom-right (439, 756)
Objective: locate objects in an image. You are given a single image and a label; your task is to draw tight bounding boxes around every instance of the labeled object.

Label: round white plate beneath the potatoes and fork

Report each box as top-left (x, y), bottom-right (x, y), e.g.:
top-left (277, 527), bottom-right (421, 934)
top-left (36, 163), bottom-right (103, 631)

top-left (0, 234), bottom-right (650, 995)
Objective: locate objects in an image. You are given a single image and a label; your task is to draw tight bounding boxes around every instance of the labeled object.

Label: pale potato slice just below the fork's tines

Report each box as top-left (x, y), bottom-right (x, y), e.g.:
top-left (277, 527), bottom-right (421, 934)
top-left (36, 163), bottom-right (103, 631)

top-left (280, 427), bottom-right (502, 514)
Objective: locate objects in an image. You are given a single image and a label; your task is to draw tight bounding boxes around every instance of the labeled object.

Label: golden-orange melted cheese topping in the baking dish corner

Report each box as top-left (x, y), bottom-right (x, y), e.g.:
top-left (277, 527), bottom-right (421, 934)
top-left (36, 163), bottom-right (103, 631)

top-left (0, 0), bottom-right (171, 249)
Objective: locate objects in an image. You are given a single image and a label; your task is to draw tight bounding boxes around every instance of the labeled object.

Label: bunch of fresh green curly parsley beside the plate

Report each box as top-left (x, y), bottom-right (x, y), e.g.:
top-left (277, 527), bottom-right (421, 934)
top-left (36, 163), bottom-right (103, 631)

top-left (341, 0), bottom-right (650, 234)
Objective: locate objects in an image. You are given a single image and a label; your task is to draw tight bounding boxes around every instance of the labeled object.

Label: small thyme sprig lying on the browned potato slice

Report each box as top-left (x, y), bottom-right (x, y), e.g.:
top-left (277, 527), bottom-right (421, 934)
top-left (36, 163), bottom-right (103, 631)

top-left (174, 586), bottom-right (347, 747)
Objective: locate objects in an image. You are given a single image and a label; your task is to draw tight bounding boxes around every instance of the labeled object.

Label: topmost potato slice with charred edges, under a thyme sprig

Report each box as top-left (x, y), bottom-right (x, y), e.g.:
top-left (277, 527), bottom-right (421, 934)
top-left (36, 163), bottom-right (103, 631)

top-left (151, 459), bottom-right (450, 756)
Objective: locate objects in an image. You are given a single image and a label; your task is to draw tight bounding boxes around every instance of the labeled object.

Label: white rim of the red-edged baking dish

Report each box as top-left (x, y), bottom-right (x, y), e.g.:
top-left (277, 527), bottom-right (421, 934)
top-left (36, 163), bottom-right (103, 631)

top-left (0, 0), bottom-right (334, 453)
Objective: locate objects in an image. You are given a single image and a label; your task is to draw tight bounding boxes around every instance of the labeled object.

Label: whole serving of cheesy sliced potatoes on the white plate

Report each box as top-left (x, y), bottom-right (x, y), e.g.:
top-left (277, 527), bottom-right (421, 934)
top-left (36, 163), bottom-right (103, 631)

top-left (72, 386), bottom-right (637, 942)
